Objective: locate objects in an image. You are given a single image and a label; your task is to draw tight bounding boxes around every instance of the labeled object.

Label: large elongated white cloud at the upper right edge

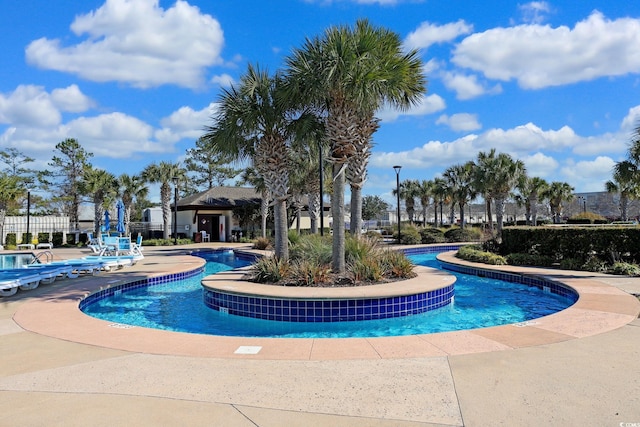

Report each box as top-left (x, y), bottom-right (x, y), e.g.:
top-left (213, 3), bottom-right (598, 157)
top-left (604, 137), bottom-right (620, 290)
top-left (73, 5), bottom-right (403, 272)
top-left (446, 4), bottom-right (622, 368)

top-left (452, 11), bottom-right (640, 89)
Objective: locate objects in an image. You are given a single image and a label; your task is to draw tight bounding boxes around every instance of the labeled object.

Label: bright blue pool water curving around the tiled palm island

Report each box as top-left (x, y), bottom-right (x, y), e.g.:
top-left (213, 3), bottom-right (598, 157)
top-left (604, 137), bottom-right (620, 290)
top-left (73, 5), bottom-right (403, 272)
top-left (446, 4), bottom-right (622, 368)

top-left (83, 252), bottom-right (573, 338)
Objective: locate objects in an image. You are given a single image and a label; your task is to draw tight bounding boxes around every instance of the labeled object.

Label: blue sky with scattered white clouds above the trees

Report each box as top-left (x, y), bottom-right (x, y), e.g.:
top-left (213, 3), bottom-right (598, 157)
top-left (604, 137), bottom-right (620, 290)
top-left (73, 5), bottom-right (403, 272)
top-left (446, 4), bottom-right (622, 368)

top-left (0, 0), bottom-right (640, 206)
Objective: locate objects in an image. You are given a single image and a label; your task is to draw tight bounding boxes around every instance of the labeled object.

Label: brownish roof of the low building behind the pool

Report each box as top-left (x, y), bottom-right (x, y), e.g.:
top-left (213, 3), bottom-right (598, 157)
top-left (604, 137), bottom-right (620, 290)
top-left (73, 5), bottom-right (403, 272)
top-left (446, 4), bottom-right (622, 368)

top-left (178, 187), bottom-right (262, 210)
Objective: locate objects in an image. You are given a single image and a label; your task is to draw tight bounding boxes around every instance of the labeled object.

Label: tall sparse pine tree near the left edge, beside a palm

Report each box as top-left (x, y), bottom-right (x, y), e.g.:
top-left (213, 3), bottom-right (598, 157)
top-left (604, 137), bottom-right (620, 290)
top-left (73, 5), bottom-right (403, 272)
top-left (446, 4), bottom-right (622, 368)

top-left (38, 138), bottom-right (93, 230)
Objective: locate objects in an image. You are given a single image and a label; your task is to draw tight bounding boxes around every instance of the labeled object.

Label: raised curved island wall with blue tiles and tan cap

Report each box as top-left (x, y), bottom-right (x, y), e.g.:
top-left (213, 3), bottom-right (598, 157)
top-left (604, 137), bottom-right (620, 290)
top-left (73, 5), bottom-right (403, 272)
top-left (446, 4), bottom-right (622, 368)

top-left (201, 266), bottom-right (456, 323)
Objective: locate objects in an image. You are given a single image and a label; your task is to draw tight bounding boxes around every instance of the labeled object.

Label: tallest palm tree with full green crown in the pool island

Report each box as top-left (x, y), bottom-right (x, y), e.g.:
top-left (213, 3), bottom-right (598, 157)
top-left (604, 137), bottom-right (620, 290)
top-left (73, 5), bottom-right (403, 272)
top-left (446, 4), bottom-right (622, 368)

top-left (287, 20), bottom-right (425, 273)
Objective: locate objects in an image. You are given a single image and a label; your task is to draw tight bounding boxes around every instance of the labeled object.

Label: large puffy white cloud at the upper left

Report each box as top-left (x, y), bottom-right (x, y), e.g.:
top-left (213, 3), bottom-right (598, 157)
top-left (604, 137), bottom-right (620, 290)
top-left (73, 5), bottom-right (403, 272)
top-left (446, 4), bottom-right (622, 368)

top-left (26, 0), bottom-right (224, 88)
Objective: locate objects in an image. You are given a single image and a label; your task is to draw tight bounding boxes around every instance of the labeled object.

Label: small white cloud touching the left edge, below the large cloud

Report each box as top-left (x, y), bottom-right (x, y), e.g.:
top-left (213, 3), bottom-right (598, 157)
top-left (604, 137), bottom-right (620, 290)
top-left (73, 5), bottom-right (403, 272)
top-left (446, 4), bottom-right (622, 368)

top-left (0, 85), bottom-right (62, 127)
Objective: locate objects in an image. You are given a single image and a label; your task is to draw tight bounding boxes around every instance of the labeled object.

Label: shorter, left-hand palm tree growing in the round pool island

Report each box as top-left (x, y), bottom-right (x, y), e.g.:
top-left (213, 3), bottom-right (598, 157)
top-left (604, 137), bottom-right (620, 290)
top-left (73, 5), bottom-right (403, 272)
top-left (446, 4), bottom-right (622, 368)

top-left (202, 65), bottom-right (316, 260)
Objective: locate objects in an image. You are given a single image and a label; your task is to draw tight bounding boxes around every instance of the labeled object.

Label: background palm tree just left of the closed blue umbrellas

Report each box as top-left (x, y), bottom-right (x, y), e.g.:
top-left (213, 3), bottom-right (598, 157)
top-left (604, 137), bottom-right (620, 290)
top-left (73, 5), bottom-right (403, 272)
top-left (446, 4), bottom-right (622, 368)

top-left (78, 167), bottom-right (118, 235)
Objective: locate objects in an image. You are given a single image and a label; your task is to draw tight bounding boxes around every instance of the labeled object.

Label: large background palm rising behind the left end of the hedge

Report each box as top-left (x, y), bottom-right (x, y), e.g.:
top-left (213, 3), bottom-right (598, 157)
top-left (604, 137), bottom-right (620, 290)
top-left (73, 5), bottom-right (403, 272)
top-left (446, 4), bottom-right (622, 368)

top-left (475, 148), bottom-right (526, 240)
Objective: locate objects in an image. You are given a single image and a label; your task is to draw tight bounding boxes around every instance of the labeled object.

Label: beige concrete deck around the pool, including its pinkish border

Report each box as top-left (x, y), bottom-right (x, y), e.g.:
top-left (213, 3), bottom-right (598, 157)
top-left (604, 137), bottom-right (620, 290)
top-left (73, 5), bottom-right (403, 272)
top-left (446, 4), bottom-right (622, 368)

top-left (0, 243), bottom-right (640, 426)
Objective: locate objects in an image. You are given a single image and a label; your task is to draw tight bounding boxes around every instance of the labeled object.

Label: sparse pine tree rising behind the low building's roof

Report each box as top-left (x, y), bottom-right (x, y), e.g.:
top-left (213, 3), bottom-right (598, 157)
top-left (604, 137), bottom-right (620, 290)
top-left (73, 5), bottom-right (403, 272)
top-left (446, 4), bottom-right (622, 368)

top-left (189, 138), bottom-right (240, 195)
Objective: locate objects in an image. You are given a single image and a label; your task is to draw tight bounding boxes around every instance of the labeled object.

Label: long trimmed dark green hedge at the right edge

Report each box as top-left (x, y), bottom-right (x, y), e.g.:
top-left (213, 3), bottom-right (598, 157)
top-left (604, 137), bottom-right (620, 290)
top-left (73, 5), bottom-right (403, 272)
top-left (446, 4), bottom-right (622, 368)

top-left (500, 226), bottom-right (640, 262)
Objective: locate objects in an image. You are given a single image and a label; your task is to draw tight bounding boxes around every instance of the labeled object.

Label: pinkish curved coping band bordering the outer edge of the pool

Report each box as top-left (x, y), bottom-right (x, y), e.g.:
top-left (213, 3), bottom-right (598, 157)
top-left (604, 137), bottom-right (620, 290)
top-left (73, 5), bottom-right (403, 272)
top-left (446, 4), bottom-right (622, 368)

top-left (13, 247), bottom-right (640, 360)
